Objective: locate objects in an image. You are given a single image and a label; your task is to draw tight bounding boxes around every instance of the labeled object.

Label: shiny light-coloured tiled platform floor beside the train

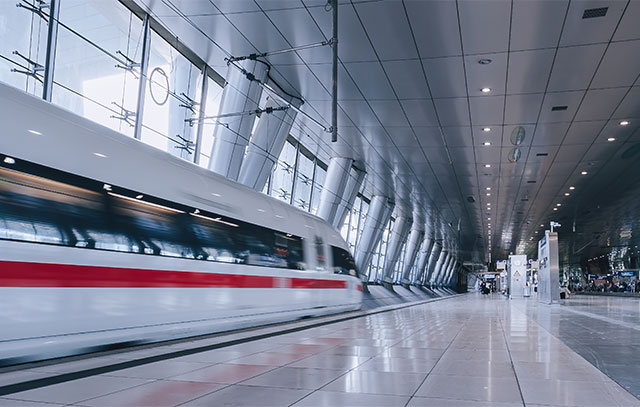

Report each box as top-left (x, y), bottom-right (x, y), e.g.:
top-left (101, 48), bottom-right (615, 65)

top-left (0, 294), bottom-right (640, 407)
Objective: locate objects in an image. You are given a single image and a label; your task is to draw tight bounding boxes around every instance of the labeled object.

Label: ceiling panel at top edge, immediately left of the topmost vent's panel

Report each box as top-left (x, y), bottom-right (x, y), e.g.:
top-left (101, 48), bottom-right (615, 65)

top-left (511, 0), bottom-right (568, 50)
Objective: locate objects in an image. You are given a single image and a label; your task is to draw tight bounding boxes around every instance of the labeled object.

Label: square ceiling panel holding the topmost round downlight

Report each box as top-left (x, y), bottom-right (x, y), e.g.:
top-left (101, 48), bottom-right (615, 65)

top-left (464, 52), bottom-right (507, 96)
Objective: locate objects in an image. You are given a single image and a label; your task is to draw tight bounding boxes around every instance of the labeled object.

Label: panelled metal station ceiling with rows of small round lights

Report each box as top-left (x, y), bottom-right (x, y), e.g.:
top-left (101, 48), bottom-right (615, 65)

top-left (135, 0), bottom-right (640, 261)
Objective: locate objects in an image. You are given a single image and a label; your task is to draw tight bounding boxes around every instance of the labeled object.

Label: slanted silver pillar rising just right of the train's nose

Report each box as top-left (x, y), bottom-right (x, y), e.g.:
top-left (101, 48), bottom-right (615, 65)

top-left (355, 195), bottom-right (395, 273)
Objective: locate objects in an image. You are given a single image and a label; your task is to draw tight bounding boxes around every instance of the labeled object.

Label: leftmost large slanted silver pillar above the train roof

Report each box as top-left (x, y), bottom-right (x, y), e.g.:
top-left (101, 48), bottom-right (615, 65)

top-left (209, 60), bottom-right (267, 181)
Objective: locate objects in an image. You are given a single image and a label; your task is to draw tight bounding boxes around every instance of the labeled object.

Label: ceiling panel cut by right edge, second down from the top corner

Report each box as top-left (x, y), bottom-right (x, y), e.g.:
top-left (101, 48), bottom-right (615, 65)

top-left (591, 39), bottom-right (640, 88)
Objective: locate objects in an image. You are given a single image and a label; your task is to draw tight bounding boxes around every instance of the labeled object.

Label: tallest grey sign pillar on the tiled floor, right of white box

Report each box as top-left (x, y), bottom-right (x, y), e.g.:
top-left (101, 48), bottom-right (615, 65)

top-left (538, 230), bottom-right (560, 304)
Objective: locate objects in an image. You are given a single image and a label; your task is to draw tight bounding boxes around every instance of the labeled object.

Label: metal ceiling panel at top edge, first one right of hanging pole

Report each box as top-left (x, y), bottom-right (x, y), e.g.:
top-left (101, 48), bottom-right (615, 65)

top-left (354, 2), bottom-right (418, 61)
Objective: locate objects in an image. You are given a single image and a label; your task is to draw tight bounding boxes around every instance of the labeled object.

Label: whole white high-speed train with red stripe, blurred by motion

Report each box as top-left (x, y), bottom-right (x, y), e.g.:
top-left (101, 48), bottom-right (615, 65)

top-left (0, 83), bottom-right (362, 365)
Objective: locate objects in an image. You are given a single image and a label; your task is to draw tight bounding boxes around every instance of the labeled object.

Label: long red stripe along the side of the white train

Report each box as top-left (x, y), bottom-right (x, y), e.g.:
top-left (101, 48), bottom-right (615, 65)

top-left (0, 261), bottom-right (347, 288)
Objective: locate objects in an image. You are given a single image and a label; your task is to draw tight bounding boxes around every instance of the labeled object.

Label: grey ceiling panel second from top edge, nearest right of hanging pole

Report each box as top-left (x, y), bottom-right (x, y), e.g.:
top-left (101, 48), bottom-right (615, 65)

top-left (382, 60), bottom-right (430, 99)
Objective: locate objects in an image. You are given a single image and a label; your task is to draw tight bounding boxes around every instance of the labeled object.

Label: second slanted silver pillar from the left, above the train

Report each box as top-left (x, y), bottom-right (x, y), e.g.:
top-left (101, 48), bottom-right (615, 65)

top-left (238, 97), bottom-right (300, 191)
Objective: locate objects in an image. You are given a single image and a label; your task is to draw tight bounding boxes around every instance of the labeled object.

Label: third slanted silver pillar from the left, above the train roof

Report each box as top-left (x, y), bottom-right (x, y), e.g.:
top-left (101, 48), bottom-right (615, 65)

top-left (317, 157), bottom-right (353, 224)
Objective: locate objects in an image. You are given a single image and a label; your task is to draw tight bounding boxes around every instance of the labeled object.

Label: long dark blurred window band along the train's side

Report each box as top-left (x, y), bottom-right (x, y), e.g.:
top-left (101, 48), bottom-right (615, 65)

top-left (0, 163), bottom-right (306, 269)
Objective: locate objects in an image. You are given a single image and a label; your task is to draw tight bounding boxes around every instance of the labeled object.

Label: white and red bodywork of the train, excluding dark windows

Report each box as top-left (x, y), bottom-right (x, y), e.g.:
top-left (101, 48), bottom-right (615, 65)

top-left (0, 84), bottom-right (362, 364)
